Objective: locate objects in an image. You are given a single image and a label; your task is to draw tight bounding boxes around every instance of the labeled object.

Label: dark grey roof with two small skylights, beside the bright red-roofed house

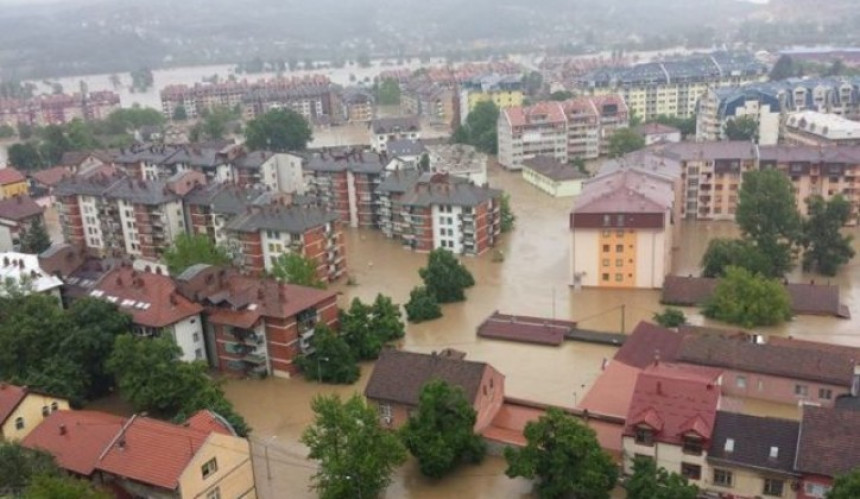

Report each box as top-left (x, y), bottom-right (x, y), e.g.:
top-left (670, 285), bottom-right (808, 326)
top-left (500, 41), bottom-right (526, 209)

top-left (708, 411), bottom-right (800, 473)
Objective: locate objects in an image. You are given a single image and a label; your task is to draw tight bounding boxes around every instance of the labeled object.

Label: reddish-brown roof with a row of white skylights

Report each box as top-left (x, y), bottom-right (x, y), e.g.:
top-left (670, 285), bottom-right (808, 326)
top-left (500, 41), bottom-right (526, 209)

top-left (90, 267), bottom-right (203, 327)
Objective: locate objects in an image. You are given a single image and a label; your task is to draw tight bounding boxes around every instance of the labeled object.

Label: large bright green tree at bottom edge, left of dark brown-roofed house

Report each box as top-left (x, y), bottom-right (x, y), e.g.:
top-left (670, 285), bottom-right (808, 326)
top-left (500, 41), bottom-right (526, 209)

top-left (301, 395), bottom-right (406, 499)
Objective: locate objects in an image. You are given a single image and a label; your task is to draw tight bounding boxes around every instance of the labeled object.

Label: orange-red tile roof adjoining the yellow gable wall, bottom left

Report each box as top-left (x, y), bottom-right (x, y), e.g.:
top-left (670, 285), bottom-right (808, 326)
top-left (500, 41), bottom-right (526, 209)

top-left (96, 417), bottom-right (209, 490)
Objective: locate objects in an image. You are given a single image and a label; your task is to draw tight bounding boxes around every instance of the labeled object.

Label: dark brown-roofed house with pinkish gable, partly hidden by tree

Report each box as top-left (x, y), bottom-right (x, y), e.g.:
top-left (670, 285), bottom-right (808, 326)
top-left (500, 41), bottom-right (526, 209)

top-left (364, 349), bottom-right (505, 433)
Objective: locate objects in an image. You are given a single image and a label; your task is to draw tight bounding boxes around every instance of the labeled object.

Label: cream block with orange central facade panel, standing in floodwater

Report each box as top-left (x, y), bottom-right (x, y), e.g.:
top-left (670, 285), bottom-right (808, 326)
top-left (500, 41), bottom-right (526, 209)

top-left (570, 169), bottom-right (675, 288)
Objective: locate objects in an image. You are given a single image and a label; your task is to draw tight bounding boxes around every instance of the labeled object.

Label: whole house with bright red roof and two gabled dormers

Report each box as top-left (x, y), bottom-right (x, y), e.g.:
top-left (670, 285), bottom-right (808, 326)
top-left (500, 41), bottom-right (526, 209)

top-left (622, 362), bottom-right (722, 485)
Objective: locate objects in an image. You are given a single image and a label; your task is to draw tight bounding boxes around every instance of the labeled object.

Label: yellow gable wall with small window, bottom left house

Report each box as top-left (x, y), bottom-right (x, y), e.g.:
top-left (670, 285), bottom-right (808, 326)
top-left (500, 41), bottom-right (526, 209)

top-left (179, 432), bottom-right (257, 499)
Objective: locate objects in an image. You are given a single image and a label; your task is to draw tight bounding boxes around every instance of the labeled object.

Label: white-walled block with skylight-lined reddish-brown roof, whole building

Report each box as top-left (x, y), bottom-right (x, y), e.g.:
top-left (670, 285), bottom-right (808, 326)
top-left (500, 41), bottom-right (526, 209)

top-left (89, 266), bottom-right (206, 362)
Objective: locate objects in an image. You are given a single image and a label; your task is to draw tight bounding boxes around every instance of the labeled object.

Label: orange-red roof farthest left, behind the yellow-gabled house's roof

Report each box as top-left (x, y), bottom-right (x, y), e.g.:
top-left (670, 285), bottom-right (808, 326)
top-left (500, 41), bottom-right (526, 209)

top-left (21, 411), bottom-right (125, 476)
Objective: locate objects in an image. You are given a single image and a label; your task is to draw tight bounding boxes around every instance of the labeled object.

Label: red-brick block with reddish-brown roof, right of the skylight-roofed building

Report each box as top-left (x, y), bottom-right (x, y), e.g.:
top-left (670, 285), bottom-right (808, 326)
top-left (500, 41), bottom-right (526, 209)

top-left (177, 264), bottom-right (338, 377)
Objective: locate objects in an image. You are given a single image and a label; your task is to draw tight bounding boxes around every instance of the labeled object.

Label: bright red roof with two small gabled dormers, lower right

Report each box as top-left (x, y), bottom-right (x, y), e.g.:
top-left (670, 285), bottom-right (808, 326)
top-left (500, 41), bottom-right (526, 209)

top-left (624, 365), bottom-right (720, 445)
